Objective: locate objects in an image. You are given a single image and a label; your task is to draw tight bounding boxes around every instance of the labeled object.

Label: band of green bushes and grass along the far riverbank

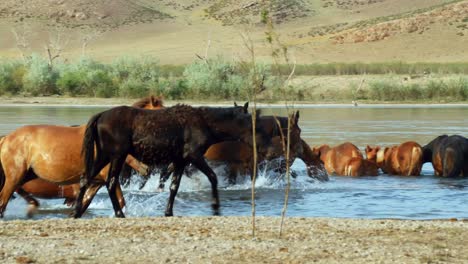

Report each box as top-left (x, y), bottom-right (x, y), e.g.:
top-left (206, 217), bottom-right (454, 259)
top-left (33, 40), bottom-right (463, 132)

top-left (0, 54), bottom-right (468, 103)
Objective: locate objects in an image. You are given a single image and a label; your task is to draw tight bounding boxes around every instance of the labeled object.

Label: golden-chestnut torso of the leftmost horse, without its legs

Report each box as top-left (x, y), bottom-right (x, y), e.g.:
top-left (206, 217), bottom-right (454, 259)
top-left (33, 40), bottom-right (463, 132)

top-left (1, 125), bottom-right (84, 182)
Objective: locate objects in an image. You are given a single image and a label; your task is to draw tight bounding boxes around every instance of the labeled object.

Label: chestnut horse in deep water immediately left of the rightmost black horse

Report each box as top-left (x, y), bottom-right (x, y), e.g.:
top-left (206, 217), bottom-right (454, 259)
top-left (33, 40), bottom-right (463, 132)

top-left (366, 141), bottom-right (423, 176)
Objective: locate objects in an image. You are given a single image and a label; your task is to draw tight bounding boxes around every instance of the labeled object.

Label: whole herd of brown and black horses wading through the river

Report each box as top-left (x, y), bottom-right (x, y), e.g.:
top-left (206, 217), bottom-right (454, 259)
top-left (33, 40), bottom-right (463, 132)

top-left (0, 96), bottom-right (468, 218)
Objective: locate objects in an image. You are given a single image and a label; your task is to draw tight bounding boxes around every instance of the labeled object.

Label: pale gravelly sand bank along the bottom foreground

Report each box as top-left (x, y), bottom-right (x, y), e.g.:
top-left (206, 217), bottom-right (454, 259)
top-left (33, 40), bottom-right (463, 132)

top-left (0, 217), bottom-right (468, 263)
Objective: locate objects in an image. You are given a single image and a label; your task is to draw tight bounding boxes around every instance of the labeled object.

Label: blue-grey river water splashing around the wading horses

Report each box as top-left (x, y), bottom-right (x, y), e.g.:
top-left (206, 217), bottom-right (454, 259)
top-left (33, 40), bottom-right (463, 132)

top-left (0, 106), bottom-right (468, 219)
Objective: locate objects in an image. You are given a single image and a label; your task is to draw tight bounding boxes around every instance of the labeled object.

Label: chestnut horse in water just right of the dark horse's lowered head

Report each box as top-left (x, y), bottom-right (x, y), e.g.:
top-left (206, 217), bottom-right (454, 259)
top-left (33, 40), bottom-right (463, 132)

top-left (312, 142), bottom-right (362, 176)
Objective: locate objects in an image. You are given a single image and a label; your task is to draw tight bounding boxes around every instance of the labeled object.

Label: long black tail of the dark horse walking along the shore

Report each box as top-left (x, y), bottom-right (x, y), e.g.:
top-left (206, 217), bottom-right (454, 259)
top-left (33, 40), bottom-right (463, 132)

top-left (81, 113), bottom-right (102, 182)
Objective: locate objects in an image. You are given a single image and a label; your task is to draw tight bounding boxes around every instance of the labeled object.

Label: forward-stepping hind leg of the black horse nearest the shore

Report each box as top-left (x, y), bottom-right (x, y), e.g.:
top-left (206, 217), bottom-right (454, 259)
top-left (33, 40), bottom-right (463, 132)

top-left (106, 156), bottom-right (125, 218)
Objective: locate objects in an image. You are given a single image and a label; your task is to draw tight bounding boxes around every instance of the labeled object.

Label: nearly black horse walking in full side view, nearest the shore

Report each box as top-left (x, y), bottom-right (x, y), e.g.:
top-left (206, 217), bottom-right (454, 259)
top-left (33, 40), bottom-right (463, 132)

top-left (74, 102), bottom-right (260, 217)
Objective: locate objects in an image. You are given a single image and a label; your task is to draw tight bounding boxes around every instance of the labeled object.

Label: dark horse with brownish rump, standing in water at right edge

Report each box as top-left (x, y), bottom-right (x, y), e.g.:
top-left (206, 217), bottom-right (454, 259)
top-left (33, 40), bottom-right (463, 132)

top-left (423, 135), bottom-right (468, 177)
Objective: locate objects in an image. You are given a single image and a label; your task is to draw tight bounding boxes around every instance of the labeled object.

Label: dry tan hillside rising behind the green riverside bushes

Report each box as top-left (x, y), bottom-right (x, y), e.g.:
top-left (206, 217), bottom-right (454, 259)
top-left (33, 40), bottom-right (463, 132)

top-left (0, 0), bottom-right (468, 64)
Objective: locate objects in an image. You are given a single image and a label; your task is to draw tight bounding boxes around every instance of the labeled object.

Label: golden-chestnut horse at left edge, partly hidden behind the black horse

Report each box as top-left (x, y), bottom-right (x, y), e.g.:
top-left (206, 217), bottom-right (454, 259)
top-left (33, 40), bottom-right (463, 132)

top-left (0, 96), bottom-right (163, 216)
